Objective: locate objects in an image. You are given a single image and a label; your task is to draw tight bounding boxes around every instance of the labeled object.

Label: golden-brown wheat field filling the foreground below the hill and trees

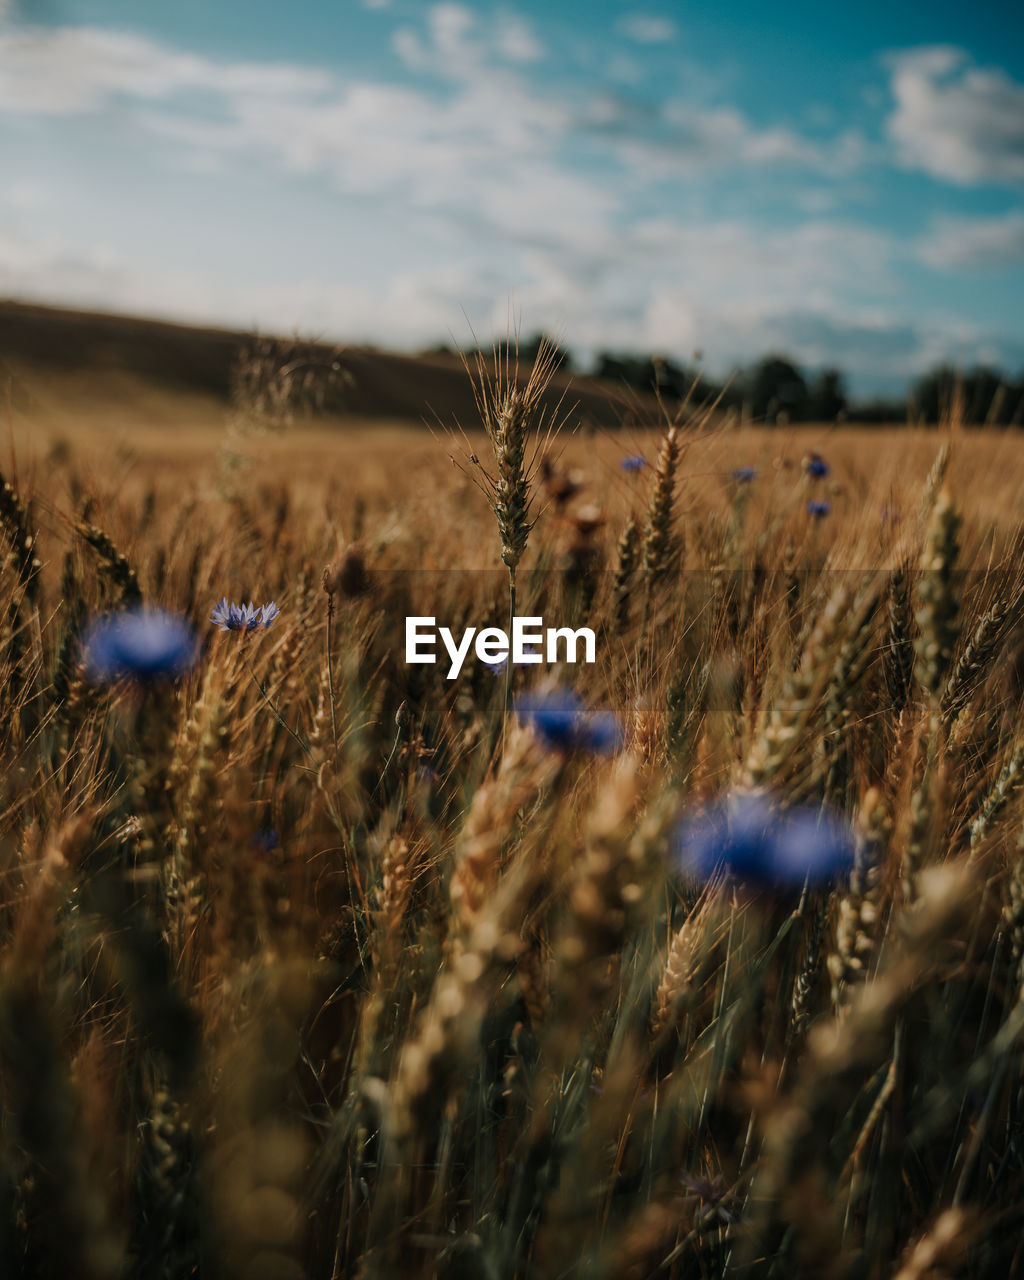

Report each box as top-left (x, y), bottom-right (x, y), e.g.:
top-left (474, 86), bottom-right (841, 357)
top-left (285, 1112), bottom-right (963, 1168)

top-left (0, 361), bottom-right (1024, 1280)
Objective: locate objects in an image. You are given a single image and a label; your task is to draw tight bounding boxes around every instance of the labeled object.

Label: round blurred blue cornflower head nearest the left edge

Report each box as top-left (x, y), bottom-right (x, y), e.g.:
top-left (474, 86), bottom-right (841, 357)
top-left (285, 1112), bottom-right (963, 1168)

top-left (82, 605), bottom-right (200, 682)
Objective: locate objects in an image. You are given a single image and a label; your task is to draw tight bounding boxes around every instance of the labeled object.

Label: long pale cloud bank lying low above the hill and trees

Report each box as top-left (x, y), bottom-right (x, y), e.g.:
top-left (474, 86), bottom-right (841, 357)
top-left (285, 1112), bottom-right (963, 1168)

top-left (0, 195), bottom-right (1006, 389)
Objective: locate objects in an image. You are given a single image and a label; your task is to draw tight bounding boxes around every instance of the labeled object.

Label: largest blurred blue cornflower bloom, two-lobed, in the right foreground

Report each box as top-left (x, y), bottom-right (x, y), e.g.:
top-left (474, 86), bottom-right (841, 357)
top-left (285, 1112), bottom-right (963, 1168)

top-left (673, 791), bottom-right (856, 890)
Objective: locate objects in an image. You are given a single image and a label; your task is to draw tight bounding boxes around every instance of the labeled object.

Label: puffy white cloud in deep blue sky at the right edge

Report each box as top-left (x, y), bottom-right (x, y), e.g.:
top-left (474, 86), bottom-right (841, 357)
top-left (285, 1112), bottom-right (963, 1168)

top-left (886, 45), bottom-right (1024, 186)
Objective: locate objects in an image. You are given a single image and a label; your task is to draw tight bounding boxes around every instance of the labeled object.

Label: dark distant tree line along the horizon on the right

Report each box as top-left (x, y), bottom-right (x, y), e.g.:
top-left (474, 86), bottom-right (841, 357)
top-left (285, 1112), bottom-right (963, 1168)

top-left (422, 333), bottom-right (1024, 426)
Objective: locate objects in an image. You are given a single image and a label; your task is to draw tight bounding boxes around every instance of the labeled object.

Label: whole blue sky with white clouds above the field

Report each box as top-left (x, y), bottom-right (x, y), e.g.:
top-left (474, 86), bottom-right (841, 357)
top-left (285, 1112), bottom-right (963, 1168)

top-left (0, 0), bottom-right (1024, 397)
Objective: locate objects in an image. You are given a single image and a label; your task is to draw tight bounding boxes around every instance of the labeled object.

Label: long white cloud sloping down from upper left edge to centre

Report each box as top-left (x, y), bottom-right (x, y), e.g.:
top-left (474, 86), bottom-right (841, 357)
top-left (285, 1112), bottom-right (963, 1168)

top-left (0, 20), bottom-right (583, 236)
